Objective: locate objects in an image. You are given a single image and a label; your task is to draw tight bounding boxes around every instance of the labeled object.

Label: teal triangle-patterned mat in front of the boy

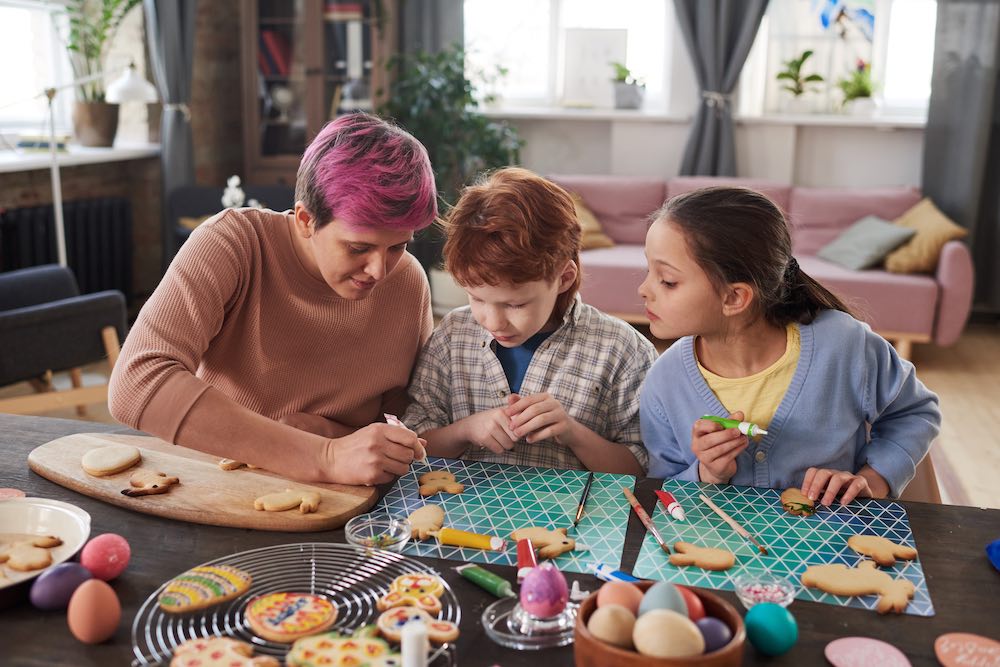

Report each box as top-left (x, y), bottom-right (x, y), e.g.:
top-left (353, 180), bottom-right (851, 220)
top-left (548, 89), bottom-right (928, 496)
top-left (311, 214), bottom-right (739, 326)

top-left (372, 457), bottom-right (635, 572)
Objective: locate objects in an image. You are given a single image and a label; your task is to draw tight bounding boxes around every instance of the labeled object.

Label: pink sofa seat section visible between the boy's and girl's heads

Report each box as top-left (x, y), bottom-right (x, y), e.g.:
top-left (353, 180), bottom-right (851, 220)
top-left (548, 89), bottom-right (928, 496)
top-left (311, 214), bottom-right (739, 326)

top-left (580, 244), bottom-right (646, 316)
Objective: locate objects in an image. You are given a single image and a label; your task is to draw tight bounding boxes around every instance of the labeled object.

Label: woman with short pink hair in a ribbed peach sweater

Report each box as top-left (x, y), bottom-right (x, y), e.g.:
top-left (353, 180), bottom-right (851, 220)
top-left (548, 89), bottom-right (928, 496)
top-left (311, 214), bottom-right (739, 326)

top-left (108, 113), bottom-right (437, 485)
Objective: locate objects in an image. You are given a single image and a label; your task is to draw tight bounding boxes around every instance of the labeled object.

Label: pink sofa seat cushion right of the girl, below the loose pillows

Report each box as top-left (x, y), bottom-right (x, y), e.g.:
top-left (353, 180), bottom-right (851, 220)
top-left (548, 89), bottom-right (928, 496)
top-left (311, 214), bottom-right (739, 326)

top-left (796, 255), bottom-right (939, 335)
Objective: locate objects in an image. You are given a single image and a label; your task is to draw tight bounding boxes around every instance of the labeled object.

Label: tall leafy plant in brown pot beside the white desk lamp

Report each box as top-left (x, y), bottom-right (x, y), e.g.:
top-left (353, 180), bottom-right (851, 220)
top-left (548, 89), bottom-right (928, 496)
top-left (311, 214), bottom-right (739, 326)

top-left (64, 0), bottom-right (142, 146)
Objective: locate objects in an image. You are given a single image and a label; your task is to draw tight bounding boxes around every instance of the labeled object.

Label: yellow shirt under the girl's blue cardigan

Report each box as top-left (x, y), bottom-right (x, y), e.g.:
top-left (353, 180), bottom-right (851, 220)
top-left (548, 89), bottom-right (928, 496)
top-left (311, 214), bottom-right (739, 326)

top-left (698, 322), bottom-right (802, 431)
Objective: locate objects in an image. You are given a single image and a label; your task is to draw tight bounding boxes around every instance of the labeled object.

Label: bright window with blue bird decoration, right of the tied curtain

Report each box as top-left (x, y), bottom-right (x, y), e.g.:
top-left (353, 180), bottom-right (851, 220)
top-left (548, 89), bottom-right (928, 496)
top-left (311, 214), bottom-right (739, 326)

top-left (739, 0), bottom-right (937, 115)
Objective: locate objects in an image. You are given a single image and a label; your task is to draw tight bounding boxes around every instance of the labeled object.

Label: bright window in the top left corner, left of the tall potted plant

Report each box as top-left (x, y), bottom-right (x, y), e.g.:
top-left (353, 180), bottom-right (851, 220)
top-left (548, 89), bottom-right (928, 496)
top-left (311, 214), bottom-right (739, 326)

top-left (0, 0), bottom-right (73, 134)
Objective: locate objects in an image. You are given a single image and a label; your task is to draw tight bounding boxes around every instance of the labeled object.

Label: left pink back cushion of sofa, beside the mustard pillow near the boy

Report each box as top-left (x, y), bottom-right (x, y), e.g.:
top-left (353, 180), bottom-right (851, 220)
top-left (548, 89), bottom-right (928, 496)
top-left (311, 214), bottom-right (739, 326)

top-left (549, 175), bottom-right (667, 245)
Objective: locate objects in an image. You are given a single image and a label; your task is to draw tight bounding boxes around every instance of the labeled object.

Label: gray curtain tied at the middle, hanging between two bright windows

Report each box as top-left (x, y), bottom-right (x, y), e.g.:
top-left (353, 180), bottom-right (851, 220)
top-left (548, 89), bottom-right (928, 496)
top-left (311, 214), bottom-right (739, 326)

top-left (674, 0), bottom-right (768, 176)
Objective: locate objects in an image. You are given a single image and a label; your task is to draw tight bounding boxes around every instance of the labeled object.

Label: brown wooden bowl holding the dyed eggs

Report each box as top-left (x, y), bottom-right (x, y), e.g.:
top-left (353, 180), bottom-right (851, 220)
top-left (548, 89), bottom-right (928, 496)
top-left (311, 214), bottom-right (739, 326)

top-left (573, 581), bottom-right (747, 667)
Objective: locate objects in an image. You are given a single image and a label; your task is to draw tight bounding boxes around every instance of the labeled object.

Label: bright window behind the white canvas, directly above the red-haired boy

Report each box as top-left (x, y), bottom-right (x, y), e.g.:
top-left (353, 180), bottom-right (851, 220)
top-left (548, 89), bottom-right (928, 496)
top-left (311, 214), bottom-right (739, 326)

top-left (464, 0), bottom-right (673, 109)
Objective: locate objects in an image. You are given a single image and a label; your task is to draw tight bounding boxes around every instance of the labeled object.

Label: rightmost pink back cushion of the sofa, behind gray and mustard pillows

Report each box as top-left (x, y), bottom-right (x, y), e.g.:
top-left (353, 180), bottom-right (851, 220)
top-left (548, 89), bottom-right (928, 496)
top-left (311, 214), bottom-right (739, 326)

top-left (787, 187), bottom-right (920, 255)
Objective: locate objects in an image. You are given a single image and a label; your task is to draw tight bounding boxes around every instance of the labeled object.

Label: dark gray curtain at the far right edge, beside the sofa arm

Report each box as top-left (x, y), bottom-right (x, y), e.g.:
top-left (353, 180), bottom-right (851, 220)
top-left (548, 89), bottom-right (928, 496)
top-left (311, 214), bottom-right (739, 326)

top-left (923, 0), bottom-right (1000, 314)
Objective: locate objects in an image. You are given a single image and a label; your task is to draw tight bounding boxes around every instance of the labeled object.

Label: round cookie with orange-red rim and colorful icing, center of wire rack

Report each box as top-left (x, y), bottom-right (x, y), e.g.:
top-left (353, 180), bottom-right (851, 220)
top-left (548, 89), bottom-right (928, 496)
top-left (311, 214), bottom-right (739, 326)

top-left (246, 593), bottom-right (337, 644)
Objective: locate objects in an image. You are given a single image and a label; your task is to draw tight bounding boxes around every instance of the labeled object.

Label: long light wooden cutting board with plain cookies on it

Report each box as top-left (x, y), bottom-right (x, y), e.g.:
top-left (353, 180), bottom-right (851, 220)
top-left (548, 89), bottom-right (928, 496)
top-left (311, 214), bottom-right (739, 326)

top-left (28, 433), bottom-right (377, 532)
